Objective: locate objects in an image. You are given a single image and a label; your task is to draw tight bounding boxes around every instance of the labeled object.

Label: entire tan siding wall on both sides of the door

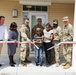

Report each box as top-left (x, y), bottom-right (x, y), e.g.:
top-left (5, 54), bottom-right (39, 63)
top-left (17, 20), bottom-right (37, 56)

top-left (0, 0), bottom-right (74, 54)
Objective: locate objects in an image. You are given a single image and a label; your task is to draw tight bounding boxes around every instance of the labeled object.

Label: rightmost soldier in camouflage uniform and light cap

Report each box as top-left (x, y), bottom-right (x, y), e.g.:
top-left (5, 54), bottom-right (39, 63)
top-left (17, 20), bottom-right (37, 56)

top-left (62, 16), bottom-right (73, 69)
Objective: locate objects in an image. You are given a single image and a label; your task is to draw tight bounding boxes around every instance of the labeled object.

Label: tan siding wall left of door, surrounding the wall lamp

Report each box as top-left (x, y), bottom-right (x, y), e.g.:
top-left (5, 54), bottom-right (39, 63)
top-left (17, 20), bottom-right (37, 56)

top-left (0, 0), bottom-right (22, 27)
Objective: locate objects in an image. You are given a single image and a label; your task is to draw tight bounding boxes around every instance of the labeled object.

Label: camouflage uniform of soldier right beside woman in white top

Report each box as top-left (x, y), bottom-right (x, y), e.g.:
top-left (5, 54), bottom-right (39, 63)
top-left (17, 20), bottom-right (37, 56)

top-left (53, 26), bottom-right (61, 63)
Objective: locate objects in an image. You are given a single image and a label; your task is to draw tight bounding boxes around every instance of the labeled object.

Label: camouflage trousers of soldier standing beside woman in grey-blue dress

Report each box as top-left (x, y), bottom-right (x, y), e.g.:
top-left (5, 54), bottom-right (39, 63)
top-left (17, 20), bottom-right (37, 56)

top-left (20, 44), bottom-right (29, 61)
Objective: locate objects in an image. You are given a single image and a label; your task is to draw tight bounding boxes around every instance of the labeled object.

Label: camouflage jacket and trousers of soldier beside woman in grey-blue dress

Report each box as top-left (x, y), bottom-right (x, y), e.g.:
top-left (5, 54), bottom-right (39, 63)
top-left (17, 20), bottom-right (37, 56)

top-left (20, 24), bottom-right (30, 61)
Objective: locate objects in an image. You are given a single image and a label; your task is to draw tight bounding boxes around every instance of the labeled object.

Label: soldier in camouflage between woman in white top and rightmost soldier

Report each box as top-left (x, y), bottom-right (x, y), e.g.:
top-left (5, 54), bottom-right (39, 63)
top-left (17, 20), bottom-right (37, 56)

top-left (53, 19), bottom-right (61, 67)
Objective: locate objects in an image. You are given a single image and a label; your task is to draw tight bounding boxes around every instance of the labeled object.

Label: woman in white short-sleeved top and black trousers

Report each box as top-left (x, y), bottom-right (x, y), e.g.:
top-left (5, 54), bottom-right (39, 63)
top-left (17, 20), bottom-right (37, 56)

top-left (42, 23), bottom-right (53, 65)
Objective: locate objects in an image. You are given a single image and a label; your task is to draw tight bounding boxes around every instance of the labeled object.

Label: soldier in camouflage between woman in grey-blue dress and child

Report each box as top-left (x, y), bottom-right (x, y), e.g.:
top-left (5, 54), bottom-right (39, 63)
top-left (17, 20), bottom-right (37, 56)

top-left (20, 18), bottom-right (31, 66)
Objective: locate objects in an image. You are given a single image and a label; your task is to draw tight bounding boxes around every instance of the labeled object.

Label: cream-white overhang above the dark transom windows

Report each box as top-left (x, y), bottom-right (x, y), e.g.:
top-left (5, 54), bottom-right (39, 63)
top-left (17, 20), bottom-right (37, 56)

top-left (19, 0), bottom-right (51, 6)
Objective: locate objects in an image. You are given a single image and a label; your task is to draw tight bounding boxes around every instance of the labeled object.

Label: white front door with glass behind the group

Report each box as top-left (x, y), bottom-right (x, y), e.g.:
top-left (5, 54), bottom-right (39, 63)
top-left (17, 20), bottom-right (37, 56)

top-left (23, 12), bottom-right (48, 50)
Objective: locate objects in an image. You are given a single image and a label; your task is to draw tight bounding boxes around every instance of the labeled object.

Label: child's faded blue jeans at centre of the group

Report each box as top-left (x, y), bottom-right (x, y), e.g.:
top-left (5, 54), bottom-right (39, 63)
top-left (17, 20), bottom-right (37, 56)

top-left (35, 46), bottom-right (43, 64)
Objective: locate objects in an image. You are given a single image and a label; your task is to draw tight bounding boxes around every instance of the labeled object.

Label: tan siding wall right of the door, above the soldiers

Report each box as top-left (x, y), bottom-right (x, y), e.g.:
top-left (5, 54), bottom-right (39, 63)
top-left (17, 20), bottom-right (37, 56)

top-left (48, 4), bottom-right (74, 26)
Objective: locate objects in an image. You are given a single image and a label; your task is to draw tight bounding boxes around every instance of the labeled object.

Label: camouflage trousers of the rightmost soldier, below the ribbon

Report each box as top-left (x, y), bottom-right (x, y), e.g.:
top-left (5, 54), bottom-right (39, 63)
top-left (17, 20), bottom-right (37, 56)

top-left (63, 44), bottom-right (73, 62)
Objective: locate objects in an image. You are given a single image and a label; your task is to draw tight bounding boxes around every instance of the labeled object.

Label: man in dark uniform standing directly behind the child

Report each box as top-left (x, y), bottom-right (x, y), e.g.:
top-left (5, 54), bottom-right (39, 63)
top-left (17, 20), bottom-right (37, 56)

top-left (32, 18), bottom-right (44, 39)
